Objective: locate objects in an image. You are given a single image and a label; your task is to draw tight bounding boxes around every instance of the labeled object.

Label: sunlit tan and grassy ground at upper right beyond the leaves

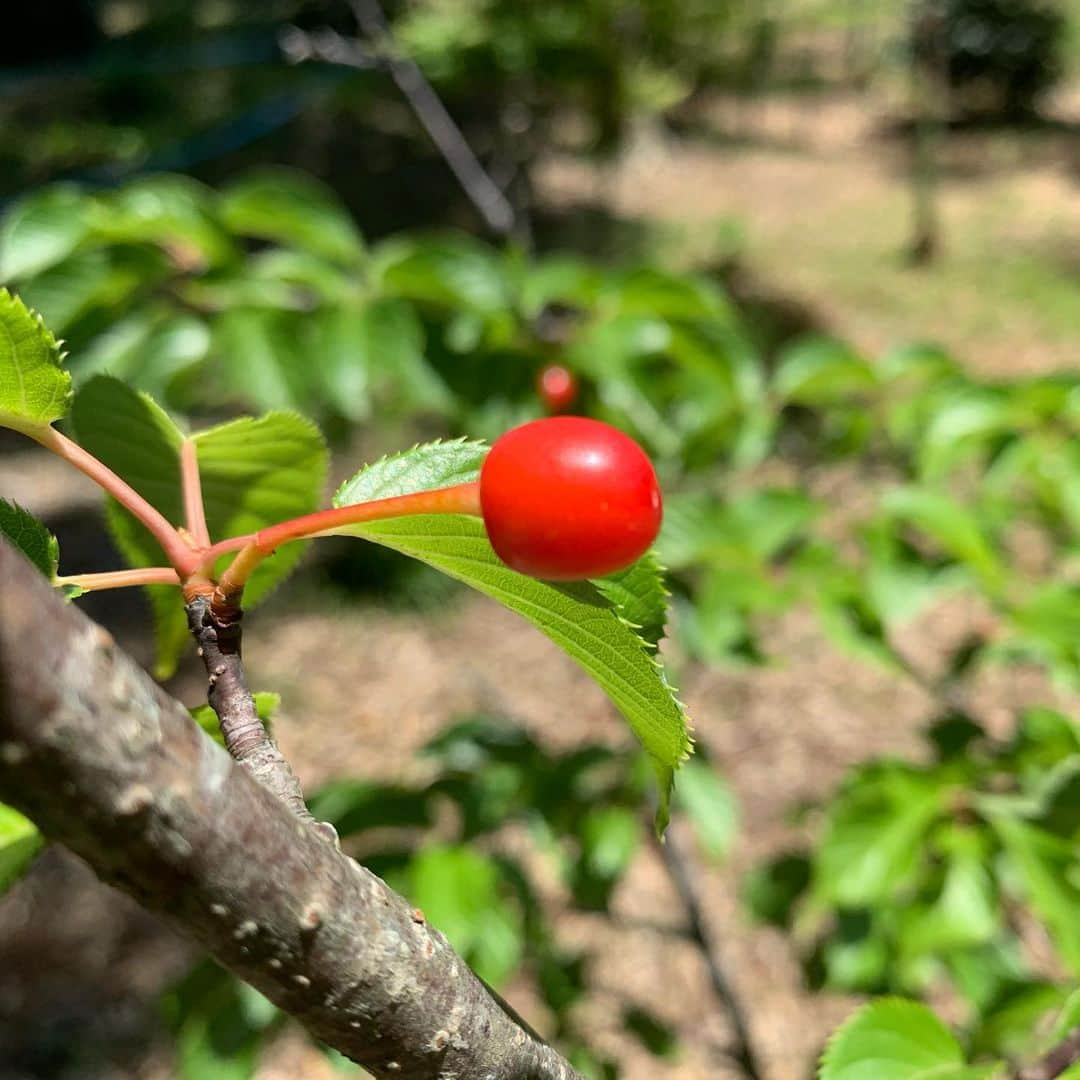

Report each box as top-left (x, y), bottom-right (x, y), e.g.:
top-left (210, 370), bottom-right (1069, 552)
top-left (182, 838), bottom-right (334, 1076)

top-left (539, 91), bottom-right (1080, 375)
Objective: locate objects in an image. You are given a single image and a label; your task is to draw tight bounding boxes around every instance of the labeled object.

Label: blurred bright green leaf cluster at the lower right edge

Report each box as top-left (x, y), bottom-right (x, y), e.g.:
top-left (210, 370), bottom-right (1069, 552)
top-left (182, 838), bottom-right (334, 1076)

top-left (745, 708), bottom-right (1080, 1058)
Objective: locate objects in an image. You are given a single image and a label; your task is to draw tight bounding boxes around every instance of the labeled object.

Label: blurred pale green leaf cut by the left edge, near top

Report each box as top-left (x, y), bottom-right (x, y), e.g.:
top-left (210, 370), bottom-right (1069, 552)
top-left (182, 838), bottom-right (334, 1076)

top-left (0, 184), bottom-right (90, 282)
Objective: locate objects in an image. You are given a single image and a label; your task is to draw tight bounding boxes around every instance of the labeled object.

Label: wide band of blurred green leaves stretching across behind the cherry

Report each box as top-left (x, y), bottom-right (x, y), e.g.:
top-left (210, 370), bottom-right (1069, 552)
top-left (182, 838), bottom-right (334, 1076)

top-left (12, 173), bottom-right (1080, 679)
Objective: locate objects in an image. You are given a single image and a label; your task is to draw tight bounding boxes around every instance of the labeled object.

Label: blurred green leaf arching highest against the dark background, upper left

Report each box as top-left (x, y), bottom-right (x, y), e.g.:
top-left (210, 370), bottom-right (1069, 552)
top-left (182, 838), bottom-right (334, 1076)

top-left (220, 167), bottom-right (364, 266)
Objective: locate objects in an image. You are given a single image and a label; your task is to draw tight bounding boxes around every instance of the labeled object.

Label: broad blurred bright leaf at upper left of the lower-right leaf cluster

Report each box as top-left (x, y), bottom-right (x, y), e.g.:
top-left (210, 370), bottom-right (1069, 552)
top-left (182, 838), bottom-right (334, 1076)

top-left (814, 762), bottom-right (944, 908)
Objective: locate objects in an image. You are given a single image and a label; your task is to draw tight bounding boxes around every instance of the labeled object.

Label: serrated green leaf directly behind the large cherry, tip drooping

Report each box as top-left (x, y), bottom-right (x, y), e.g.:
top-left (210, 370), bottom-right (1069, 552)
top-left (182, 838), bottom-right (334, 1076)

top-left (334, 441), bottom-right (690, 824)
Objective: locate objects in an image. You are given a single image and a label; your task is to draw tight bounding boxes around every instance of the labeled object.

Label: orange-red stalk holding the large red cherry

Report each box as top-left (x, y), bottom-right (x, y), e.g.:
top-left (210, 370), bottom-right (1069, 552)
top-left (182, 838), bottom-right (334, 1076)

top-left (212, 482), bottom-right (481, 608)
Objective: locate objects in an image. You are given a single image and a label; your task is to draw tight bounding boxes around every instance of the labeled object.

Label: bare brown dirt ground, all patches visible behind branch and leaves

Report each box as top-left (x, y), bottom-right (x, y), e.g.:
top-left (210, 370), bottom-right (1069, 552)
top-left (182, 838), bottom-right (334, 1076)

top-left (0, 90), bottom-right (1080, 1080)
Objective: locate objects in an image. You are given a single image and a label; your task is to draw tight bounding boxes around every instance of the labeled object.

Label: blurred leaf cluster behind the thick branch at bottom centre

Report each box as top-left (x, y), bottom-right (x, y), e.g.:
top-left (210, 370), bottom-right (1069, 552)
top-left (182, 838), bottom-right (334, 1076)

top-left (165, 717), bottom-right (735, 1080)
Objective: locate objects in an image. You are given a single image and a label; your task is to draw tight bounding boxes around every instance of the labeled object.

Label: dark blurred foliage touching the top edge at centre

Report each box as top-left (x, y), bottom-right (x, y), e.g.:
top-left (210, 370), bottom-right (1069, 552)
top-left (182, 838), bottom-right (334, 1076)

top-left (394, 0), bottom-right (746, 158)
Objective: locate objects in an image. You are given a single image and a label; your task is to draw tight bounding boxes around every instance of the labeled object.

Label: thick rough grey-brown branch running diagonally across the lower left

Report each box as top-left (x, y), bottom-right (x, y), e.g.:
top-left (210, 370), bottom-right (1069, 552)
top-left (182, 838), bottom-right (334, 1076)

top-left (0, 542), bottom-right (580, 1080)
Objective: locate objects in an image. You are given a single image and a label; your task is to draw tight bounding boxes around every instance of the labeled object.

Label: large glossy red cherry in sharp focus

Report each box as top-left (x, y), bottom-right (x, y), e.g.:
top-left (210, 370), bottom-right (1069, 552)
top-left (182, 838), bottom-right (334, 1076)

top-left (480, 416), bottom-right (663, 581)
